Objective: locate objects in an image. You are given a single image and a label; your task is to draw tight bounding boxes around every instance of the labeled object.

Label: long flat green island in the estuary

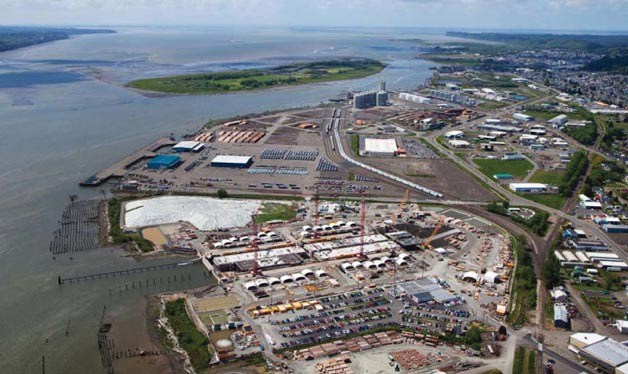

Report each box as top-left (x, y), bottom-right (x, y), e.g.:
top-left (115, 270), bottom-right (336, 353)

top-left (127, 58), bottom-right (386, 94)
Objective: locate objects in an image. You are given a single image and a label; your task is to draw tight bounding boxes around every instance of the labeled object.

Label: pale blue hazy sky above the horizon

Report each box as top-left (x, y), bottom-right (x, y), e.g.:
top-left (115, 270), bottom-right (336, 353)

top-left (0, 0), bottom-right (628, 31)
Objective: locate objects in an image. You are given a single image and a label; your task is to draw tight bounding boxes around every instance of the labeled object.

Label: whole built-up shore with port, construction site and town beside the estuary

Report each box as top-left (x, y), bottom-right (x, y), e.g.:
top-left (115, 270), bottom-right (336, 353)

top-left (56, 43), bottom-right (628, 373)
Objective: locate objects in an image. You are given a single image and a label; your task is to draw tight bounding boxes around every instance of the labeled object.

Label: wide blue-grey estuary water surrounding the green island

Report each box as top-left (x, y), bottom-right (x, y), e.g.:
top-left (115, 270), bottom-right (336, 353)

top-left (0, 27), bottom-right (433, 374)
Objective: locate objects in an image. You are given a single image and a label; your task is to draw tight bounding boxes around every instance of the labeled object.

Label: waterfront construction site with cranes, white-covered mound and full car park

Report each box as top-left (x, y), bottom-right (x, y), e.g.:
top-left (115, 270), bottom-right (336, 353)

top-left (116, 186), bottom-right (514, 372)
